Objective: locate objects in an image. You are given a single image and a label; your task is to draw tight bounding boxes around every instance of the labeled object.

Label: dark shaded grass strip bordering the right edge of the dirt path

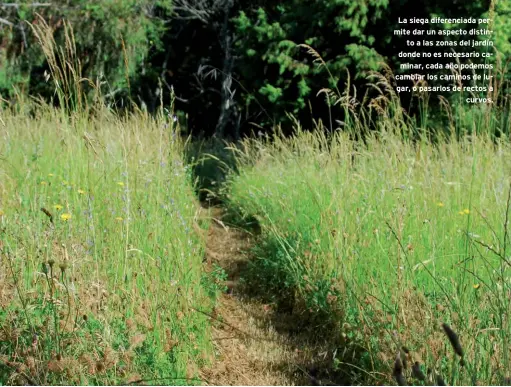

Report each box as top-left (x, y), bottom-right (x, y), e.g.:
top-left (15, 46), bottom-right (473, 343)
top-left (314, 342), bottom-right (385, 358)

top-left (206, 206), bottom-right (375, 385)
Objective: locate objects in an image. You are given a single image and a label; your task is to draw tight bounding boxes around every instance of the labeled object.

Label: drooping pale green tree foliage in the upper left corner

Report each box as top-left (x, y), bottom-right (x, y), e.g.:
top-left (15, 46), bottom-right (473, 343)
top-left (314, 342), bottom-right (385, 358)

top-left (0, 0), bottom-right (163, 104)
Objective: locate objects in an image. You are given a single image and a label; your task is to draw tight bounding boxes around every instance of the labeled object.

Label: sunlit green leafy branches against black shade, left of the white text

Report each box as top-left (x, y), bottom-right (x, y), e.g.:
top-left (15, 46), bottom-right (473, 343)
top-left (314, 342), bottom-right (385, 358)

top-left (230, 0), bottom-right (388, 133)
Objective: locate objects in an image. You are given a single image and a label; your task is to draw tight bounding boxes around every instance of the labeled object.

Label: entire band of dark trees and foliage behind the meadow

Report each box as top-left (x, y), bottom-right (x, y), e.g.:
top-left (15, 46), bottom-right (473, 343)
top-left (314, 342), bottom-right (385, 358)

top-left (0, 0), bottom-right (511, 138)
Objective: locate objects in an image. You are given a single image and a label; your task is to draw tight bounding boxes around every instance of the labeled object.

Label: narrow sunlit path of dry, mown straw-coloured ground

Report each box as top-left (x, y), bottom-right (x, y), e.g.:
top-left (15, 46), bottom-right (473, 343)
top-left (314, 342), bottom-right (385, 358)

top-left (198, 208), bottom-right (319, 385)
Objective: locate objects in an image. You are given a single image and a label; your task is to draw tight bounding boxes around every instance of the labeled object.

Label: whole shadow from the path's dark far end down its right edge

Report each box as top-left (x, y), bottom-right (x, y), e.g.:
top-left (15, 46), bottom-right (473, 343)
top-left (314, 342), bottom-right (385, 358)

top-left (185, 139), bottom-right (375, 385)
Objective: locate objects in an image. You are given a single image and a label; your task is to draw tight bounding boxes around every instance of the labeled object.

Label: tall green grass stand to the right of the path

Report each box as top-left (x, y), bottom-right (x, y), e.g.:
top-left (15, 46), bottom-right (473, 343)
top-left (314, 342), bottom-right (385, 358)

top-left (228, 114), bottom-right (511, 384)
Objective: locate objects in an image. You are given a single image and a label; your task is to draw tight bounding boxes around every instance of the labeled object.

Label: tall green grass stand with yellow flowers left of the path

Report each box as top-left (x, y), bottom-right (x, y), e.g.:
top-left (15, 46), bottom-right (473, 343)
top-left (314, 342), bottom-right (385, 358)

top-left (0, 107), bottom-right (218, 385)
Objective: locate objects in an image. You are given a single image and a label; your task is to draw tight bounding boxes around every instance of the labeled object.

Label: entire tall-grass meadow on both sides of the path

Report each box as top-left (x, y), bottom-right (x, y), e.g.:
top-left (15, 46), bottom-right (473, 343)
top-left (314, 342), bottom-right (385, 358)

top-left (0, 13), bottom-right (511, 385)
